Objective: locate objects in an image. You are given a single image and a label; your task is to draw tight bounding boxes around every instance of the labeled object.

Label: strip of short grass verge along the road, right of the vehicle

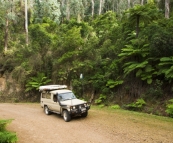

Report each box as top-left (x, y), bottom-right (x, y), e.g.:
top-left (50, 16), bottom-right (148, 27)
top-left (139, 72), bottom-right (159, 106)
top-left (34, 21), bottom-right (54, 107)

top-left (91, 106), bottom-right (173, 134)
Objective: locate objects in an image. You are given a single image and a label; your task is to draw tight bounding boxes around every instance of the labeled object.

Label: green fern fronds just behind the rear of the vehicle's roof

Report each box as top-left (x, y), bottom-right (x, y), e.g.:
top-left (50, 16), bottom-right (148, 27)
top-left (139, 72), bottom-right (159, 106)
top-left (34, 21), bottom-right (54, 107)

top-left (25, 73), bottom-right (51, 92)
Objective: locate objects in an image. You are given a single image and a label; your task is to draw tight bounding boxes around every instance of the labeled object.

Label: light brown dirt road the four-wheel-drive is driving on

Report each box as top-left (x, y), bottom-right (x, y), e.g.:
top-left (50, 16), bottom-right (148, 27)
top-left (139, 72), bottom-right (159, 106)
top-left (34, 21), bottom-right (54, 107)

top-left (0, 103), bottom-right (173, 143)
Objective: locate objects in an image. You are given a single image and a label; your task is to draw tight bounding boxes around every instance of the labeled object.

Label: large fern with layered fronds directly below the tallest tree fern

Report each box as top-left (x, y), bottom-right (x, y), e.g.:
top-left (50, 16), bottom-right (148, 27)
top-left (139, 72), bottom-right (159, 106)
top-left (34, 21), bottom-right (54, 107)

top-left (118, 39), bottom-right (157, 84)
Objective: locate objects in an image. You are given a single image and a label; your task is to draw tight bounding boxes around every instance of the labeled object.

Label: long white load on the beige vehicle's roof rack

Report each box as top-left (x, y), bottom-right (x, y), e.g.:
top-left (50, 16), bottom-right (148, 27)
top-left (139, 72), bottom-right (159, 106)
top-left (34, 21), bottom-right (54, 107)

top-left (39, 85), bottom-right (67, 91)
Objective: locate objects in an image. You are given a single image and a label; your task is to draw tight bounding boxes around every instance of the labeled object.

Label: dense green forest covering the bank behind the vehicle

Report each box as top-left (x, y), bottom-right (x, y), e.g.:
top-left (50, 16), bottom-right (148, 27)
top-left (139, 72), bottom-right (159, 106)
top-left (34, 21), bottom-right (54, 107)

top-left (0, 0), bottom-right (173, 115)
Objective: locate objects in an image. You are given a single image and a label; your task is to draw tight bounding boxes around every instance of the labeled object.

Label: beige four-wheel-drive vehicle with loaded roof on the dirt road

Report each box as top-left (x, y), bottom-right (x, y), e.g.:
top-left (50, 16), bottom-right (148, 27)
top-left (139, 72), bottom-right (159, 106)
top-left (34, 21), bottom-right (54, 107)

top-left (39, 85), bottom-right (90, 122)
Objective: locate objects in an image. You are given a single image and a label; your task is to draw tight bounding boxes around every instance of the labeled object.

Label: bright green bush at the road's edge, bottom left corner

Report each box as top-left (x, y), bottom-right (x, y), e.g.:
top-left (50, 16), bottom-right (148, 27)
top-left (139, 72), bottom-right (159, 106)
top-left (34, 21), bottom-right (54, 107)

top-left (0, 120), bottom-right (17, 143)
